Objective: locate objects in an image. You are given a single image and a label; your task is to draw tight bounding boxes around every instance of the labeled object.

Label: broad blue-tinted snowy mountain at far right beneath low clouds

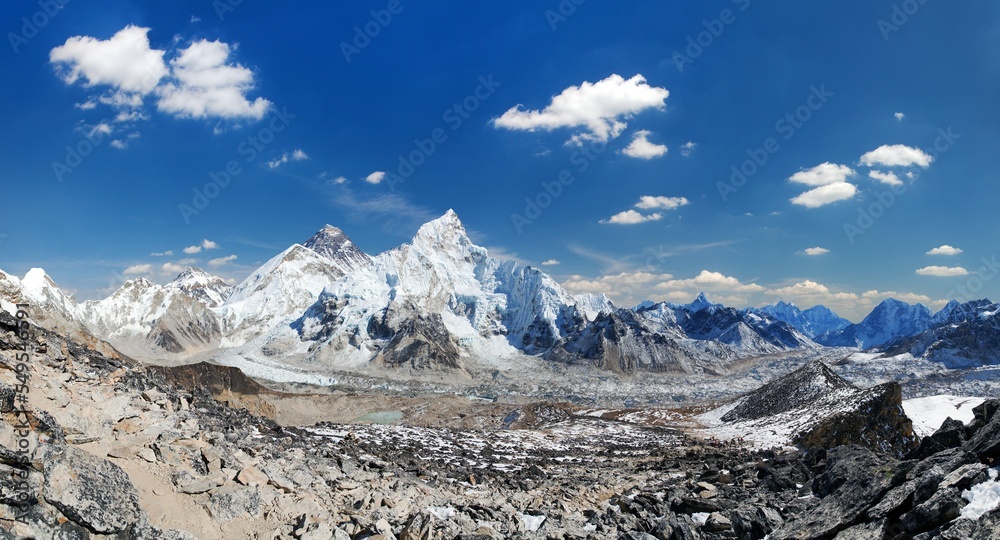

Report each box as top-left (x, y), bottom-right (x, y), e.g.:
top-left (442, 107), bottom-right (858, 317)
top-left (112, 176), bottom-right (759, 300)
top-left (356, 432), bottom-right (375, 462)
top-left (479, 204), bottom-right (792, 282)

top-left (816, 298), bottom-right (934, 349)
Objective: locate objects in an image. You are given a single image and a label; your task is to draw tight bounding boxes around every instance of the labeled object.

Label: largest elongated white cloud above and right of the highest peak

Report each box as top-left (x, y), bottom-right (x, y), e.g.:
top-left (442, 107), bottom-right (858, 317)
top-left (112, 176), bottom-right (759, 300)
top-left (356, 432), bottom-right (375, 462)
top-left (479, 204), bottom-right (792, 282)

top-left (493, 74), bottom-right (670, 144)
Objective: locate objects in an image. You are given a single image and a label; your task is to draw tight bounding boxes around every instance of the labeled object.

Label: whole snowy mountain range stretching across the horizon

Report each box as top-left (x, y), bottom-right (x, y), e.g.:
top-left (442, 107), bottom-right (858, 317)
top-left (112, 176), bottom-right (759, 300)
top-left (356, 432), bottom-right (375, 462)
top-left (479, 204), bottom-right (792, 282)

top-left (0, 211), bottom-right (1000, 380)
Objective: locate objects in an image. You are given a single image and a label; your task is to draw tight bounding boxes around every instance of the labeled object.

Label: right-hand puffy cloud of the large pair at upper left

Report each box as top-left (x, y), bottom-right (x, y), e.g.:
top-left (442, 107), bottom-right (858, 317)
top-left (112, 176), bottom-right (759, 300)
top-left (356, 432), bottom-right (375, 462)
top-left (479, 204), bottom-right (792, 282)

top-left (156, 39), bottom-right (271, 120)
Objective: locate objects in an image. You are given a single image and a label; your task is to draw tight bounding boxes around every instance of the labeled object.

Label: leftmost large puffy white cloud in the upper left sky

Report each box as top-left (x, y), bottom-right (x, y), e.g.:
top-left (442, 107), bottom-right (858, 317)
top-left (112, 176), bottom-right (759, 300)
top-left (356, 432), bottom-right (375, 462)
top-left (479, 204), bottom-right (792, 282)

top-left (49, 25), bottom-right (167, 95)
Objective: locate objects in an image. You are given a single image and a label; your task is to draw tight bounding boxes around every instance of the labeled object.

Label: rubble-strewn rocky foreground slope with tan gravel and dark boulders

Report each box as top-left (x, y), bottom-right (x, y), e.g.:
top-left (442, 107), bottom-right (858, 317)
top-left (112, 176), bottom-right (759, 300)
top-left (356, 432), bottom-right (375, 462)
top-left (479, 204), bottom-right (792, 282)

top-left (0, 313), bottom-right (1000, 540)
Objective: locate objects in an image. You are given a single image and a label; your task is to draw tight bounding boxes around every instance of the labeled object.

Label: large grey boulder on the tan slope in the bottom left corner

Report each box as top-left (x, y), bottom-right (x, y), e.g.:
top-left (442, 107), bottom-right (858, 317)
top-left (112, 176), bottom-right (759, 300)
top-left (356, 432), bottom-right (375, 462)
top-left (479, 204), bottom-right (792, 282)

top-left (43, 447), bottom-right (140, 534)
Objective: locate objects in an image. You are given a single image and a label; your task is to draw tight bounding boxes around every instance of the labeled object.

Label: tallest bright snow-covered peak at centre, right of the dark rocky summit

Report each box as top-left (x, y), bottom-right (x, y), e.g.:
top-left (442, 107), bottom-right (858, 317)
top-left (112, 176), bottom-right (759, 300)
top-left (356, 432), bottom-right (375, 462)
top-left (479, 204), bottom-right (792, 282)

top-left (286, 211), bottom-right (611, 372)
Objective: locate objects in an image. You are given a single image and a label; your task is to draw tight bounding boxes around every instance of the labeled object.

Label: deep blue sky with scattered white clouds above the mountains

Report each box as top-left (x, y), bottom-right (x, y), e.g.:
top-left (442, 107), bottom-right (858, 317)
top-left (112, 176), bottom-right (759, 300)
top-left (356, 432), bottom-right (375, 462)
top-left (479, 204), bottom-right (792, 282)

top-left (0, 0), bottom-right (1000, 319)
